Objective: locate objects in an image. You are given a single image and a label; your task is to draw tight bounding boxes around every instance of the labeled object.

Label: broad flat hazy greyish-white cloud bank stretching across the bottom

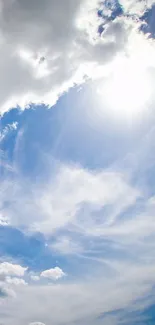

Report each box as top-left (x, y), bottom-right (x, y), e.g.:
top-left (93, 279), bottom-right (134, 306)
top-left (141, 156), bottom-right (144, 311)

top-left (0, 264), bottom-right (155, 325)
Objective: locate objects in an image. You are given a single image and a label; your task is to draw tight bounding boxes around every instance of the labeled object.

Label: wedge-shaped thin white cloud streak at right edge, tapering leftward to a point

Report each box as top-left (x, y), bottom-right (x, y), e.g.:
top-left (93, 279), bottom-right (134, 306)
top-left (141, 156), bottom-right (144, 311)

top-left (84, 192), bottom-right (155, 240)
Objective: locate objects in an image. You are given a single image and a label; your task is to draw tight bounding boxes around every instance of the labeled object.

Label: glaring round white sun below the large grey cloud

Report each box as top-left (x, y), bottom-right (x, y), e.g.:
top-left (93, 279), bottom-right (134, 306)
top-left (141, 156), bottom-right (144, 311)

top-left (99, 59), bottom-right (151, 119)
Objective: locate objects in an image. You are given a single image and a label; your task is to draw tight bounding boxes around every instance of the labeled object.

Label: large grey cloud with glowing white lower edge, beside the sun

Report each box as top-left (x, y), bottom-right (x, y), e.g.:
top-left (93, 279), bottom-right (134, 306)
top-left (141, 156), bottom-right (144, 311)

top-left (0, 0), bottom-right (152, 112)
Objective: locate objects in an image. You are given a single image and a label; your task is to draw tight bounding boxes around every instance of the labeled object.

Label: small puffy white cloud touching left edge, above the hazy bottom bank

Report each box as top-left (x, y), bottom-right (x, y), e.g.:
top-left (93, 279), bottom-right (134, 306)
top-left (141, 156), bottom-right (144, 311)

top-left (0, 262), bottom-right (27, 277)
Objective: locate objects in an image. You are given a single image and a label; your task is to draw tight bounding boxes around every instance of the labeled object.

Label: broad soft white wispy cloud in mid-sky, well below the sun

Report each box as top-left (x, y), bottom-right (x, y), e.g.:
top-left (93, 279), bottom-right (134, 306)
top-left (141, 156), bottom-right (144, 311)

top-left (1, 165), bottom-right (141, 236)
